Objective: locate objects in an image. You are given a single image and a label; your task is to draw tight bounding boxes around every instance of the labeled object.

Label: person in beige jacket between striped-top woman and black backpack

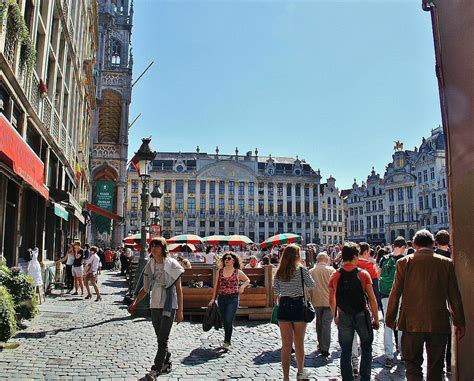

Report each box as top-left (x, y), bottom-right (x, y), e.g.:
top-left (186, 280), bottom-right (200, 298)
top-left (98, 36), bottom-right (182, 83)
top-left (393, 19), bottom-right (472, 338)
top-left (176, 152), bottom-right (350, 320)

top-left (309, 251), bottom-right (336, 357)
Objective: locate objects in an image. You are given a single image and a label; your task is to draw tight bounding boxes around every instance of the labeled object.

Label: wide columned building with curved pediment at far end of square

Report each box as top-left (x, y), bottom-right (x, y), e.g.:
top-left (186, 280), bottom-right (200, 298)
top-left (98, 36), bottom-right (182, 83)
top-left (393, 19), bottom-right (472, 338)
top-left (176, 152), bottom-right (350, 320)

top-left (126, 148), bottom-right (343, 243)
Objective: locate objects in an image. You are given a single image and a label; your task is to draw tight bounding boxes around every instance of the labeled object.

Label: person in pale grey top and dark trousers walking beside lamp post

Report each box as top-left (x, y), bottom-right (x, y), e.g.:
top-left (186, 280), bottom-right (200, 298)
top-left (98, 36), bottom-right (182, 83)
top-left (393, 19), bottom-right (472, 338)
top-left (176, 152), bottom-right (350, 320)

top-left (128, 237), bottom-right (184, 381)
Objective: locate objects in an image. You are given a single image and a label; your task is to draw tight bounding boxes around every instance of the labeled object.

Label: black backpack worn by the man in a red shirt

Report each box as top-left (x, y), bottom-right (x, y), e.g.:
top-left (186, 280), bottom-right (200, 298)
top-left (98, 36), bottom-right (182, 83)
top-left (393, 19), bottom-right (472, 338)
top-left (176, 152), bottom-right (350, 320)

top-left (336, 268), bottom-right (367, 315)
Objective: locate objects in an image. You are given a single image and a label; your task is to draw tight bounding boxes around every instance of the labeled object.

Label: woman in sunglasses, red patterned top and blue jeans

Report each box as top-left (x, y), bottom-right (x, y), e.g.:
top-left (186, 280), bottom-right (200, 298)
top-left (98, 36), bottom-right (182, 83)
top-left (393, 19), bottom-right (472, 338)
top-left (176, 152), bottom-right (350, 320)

top-left (209, 252), bottom-right (250, 348)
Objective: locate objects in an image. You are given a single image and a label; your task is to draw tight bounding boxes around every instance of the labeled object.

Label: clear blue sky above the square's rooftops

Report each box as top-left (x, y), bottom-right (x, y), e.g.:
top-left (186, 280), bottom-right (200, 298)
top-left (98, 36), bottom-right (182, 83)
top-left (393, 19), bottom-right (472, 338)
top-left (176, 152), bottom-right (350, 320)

top-left (129, 0), bottom-right (441, 188)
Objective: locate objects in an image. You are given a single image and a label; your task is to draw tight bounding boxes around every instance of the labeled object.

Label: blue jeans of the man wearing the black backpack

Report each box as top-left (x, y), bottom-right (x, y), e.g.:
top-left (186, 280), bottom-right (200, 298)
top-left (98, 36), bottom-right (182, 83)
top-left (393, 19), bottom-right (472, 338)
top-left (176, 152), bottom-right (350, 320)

top-left (337, 311), bottom-right (374, 381)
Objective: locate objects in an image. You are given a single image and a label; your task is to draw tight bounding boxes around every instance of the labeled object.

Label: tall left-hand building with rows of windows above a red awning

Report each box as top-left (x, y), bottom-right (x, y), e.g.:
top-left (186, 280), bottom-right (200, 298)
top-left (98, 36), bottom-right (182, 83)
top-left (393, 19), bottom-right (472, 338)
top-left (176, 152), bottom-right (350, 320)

top-left (0, 0), bottom-right (98, 266)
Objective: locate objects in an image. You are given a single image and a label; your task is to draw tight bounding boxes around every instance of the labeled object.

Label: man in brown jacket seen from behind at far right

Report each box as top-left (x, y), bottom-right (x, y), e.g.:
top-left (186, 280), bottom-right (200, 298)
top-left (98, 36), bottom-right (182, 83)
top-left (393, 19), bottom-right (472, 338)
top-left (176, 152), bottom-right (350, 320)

top-left (385, 229), bottom-right (466, 381)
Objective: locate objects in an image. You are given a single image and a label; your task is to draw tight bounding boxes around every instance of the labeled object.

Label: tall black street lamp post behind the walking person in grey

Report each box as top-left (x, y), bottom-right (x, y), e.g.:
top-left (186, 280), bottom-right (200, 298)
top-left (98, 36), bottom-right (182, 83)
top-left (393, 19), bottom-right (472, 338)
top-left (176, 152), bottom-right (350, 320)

top-left (134, 138), bottom-right (156, 316)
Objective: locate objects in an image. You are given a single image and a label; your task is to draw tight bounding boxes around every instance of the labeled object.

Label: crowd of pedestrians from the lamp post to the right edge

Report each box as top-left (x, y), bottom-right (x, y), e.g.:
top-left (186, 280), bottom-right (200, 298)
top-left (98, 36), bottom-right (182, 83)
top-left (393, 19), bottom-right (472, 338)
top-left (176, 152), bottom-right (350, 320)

top-left (123, 229), bottom-right (466, 381)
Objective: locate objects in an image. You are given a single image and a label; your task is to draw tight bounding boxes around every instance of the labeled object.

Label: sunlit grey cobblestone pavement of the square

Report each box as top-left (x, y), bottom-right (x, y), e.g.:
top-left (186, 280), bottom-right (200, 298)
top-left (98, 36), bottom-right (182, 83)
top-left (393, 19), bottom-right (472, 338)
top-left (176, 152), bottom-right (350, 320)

top-left (0, 272), bottom-right (452, 380)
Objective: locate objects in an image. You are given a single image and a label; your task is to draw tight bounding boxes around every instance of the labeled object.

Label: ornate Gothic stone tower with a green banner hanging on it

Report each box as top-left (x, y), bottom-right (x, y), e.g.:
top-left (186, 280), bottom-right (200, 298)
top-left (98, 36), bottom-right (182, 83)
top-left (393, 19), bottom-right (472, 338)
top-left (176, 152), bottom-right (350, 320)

top-left (90, 0), bottom-right (133, 246)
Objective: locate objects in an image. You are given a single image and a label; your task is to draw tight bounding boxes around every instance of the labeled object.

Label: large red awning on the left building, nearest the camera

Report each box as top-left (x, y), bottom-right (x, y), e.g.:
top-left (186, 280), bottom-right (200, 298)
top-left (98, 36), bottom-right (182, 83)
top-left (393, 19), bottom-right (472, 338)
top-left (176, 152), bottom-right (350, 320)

top-left (0, 114), bottom-right (49, 199)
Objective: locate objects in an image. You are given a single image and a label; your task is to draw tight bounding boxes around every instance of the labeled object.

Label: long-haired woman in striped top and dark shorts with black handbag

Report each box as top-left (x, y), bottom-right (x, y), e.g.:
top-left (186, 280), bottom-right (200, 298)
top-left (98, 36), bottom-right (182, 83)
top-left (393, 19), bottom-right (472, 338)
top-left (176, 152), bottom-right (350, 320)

top-left (273, 245), bottom-right (315, 381)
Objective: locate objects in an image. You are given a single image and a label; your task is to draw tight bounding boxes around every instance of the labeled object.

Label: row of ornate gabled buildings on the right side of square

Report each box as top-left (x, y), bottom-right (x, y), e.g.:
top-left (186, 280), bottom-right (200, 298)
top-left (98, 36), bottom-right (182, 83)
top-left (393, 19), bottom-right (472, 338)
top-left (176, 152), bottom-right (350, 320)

top-left (345, 127), bottom-right (449, 243)
